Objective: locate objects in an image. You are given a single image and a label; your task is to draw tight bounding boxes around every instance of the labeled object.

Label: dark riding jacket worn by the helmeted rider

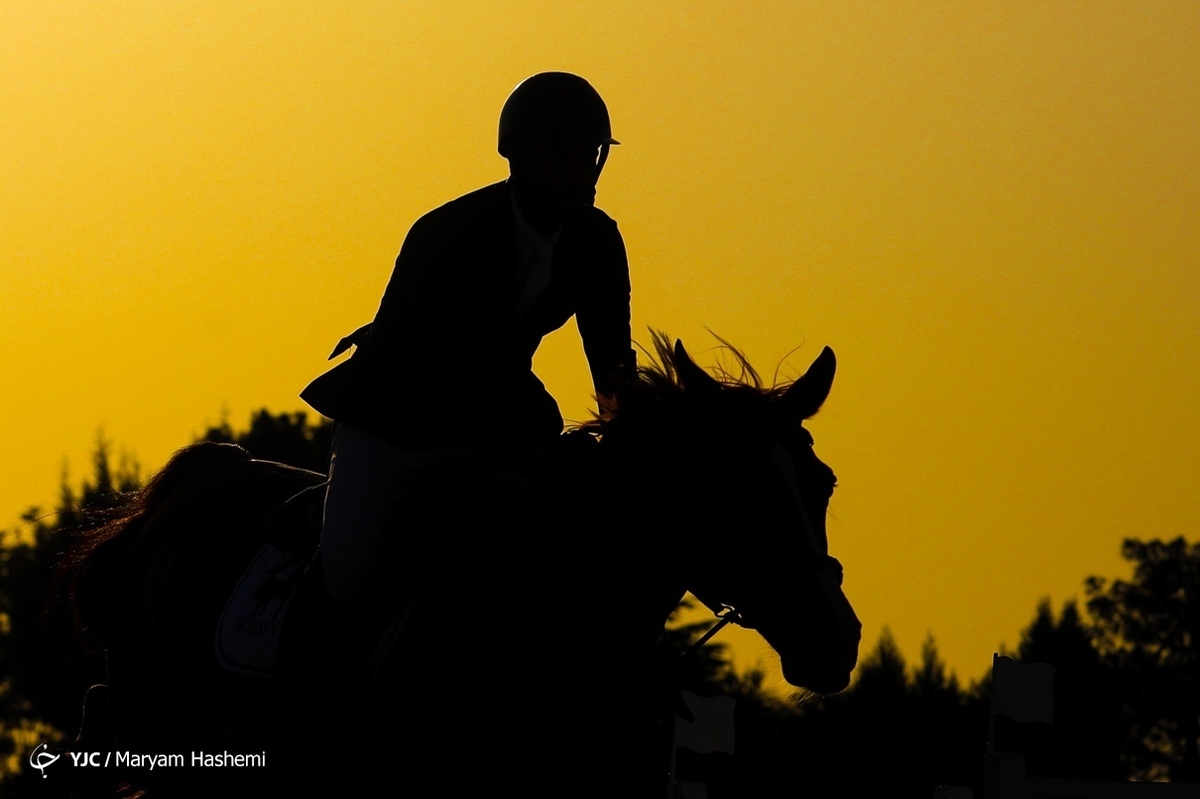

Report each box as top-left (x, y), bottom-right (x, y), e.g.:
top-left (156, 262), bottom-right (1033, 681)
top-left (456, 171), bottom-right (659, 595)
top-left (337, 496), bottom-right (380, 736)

top-left (300, 182), bottom-right (634, 451)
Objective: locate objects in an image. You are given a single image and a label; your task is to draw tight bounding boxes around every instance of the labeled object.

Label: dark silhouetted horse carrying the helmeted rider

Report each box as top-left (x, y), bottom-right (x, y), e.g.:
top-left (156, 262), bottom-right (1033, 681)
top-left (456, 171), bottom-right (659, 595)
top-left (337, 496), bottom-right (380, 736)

top-left (60, 337), bottom-right (860, 798)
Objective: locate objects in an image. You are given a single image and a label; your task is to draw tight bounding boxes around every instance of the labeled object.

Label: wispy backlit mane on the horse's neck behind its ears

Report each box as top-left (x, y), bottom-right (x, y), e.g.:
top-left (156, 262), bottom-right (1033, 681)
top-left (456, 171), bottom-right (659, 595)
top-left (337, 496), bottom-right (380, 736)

top-left (575, 330), bottom-right (793, 435)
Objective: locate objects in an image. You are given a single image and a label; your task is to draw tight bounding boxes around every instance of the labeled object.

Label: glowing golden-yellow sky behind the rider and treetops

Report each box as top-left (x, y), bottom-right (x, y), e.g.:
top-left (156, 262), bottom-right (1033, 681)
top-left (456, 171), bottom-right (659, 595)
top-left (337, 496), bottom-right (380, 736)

top-left (0, 0), bottom-right (1200, 678)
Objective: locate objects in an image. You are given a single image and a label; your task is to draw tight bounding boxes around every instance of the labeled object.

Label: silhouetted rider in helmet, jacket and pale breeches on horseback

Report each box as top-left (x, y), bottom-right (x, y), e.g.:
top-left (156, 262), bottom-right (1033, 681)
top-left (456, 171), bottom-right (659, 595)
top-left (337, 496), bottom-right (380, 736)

top-left (300, 72), bottom-right (635, 599)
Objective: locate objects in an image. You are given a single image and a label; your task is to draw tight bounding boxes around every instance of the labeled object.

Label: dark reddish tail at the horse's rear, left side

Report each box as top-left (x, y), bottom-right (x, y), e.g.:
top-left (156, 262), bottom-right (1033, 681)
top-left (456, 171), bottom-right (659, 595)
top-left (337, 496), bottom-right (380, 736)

top-left (53, 441), bottom-right (258, 647)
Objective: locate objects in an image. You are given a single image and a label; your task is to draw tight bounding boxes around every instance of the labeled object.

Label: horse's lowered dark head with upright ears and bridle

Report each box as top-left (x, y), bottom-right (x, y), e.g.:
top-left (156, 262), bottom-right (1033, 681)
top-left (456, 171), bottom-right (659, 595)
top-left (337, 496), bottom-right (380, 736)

top-left (600, 337), bottom-right (862, 693)
